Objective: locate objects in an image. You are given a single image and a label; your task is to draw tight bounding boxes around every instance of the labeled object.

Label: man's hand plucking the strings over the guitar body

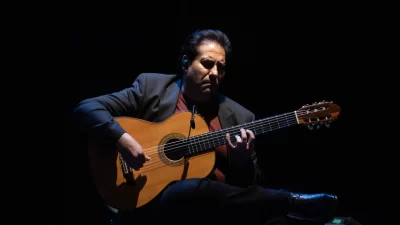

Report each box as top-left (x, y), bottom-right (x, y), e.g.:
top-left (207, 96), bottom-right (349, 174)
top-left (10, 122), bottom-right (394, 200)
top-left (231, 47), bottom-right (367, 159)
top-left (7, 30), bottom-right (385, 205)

top-left (117, 133), bottom-right (150, 170)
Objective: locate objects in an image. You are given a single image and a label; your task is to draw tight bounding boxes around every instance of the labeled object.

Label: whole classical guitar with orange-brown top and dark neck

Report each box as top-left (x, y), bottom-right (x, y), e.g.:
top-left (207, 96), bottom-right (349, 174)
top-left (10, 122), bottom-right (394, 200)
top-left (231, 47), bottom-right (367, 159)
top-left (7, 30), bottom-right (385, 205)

top-left (89, 101), bottom-right (340, 209)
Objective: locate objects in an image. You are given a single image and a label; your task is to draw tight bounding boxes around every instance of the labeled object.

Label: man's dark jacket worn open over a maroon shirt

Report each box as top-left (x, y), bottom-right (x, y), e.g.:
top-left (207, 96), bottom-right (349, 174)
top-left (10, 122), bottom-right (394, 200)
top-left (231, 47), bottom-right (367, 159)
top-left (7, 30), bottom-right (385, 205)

top-left (74, 73), bottom-right (263, 187)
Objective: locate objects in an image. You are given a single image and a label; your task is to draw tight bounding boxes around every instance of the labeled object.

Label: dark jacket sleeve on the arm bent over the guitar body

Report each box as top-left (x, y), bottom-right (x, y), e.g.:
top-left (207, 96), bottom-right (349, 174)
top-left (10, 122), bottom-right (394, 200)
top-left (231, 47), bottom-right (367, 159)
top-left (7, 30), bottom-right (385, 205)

top-left (73, 74), bottom-right (146, 141)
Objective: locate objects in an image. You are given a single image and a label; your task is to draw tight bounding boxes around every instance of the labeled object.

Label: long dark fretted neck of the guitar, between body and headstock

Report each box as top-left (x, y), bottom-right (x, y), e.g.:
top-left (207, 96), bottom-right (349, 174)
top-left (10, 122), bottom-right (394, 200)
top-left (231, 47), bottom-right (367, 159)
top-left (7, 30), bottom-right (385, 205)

top-left (187, 112), bottom-right (298, 154)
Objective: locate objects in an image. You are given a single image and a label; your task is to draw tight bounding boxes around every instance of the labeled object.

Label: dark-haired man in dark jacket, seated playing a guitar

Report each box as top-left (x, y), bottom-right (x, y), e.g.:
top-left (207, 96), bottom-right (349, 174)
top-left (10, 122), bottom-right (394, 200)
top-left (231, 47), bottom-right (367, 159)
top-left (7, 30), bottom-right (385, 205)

top-left (74, 30), bottom-right (337, 225)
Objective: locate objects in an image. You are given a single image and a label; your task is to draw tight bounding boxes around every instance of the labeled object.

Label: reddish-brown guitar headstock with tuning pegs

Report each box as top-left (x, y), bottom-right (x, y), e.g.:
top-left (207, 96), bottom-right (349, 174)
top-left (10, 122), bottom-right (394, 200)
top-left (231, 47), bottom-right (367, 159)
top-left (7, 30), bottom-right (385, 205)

top-left (296, 100), bottom-right (340, 130)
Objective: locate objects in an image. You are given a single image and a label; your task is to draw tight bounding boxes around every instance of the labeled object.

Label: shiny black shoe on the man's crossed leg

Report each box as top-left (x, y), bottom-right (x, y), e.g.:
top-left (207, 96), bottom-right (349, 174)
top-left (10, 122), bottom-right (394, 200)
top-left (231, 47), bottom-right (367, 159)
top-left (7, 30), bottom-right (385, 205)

top-left (288, 193), bottom-right (338, 222)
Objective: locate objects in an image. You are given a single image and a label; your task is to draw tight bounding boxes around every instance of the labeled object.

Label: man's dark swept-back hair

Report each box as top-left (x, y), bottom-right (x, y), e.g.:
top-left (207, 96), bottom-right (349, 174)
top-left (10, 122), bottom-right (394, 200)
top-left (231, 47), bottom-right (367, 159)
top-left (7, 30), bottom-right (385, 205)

top-left (178, 29), bottom-right (232, 74)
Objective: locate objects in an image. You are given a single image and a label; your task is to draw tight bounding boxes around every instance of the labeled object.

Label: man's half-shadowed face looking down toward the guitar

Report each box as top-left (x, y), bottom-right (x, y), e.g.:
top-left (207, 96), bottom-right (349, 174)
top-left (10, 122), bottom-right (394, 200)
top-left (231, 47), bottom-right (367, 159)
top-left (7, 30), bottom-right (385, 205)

top-left (185, 41), bottom-right (225, 99)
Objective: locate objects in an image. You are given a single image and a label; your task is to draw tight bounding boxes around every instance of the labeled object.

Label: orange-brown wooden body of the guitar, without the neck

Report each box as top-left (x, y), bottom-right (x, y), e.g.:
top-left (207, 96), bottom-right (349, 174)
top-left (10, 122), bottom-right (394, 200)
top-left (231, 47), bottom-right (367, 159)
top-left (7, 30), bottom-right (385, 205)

top-left (89, 112), bottom-right (215, 209)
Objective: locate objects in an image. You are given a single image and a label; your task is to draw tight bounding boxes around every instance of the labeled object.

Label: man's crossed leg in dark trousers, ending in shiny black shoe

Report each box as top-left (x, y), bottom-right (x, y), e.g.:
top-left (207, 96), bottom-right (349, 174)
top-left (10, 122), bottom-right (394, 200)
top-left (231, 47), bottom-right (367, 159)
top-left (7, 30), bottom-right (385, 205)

top-left (154, 179), bottom-right (336, 225)
